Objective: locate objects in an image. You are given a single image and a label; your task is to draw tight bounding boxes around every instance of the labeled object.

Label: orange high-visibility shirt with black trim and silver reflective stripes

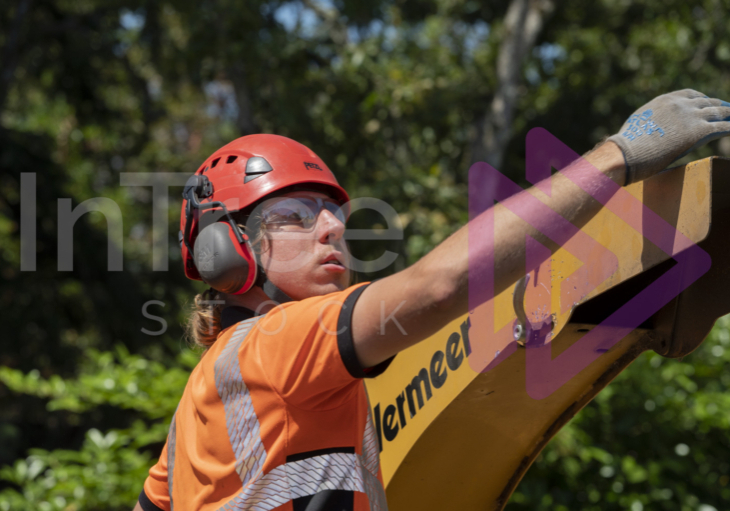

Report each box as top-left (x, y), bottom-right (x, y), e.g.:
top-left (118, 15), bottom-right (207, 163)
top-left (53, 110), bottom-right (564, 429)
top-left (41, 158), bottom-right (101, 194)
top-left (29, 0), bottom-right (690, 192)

top-left (140, 285), bottom-right (390, 511)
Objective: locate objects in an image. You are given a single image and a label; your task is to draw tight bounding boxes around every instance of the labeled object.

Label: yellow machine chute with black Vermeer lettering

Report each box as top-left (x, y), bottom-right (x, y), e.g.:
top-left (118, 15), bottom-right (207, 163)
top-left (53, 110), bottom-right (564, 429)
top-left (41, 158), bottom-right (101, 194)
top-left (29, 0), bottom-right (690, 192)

top-left (368, 158), bottom-right (730, 511)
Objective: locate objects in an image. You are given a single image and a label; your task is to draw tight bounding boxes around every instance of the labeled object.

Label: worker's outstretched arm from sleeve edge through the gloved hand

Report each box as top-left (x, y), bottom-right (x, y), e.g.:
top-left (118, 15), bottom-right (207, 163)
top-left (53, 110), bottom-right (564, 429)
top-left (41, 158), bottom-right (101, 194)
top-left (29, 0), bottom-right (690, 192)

top-left (352, 90), bottom-right (730, 367)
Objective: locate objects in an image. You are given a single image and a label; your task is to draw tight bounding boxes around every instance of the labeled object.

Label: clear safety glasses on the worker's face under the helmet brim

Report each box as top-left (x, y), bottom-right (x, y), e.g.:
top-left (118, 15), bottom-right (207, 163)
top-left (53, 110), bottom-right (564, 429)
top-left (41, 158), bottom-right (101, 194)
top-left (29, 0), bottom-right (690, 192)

top-left (261, 197), bottom-right (348, 232)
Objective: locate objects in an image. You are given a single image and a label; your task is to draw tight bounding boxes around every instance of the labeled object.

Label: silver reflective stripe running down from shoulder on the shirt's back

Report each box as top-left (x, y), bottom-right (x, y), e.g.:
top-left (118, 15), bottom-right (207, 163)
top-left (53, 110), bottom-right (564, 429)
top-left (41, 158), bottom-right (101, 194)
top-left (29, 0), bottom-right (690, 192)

top-left (215, 317), bottom-right (266, 488)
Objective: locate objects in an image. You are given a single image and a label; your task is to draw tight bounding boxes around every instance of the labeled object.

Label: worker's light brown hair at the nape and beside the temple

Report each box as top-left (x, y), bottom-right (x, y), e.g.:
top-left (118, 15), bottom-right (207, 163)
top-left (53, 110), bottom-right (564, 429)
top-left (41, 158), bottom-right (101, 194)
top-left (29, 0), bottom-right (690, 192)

top-left (185, 211), bottom-right (266, 352)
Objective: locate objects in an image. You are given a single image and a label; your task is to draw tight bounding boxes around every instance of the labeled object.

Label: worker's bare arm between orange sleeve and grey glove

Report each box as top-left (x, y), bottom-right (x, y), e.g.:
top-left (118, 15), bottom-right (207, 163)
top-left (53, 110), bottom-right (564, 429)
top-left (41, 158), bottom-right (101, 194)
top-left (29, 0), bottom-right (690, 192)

top-left (353, 142), bottom-right (625, 366)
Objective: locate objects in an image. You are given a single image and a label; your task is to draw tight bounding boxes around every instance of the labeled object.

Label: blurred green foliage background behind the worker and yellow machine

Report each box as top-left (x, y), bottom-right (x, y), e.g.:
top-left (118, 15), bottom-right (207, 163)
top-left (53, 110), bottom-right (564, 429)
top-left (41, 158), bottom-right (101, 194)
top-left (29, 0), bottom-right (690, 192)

top-left (0, 0), bottom-right (730, 511)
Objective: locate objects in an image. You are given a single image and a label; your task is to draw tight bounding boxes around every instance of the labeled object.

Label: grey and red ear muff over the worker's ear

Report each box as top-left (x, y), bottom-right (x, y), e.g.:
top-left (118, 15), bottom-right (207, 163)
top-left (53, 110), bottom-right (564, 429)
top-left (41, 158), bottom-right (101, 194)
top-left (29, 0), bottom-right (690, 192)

top-left (193, 222), bottom-right (257, 294)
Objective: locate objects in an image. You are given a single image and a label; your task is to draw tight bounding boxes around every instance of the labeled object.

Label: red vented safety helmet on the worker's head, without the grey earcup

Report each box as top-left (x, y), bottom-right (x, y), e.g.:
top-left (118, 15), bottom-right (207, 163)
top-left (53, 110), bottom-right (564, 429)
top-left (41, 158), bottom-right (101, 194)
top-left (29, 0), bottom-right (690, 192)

top-left (180, 135), bottom-right (350, 293)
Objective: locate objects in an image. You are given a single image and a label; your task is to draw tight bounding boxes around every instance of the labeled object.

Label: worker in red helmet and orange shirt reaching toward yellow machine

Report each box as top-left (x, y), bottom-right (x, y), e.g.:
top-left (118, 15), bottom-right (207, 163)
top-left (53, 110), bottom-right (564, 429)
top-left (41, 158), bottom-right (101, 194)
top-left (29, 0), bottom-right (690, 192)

top-left (135, 90), bottom-right (730, 511)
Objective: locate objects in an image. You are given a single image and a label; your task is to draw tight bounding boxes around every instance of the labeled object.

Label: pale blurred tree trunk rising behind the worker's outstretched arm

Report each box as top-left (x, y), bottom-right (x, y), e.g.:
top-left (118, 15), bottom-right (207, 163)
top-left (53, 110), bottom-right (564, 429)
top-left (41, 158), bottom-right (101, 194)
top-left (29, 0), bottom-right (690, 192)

top-left (471, 0), bottom-right (555, 169)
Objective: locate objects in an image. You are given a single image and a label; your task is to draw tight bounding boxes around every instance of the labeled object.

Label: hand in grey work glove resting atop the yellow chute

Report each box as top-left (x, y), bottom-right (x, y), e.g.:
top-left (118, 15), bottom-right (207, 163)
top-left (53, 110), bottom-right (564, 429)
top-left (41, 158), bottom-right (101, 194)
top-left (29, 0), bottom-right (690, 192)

top-left (608, 89), bottom-right (730, 184)
